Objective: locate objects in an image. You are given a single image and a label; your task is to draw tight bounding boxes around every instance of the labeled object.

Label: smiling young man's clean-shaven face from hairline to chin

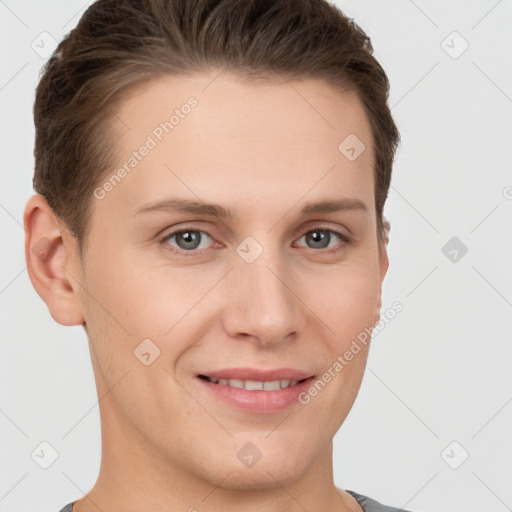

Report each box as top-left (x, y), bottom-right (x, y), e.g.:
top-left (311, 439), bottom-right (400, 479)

top-left (70, 74), bottom-right (387, 489)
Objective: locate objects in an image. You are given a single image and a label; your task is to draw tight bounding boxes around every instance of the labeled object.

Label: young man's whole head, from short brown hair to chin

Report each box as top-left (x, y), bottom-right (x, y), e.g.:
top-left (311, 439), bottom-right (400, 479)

top-left (25, 0), bottom-right (399, 496)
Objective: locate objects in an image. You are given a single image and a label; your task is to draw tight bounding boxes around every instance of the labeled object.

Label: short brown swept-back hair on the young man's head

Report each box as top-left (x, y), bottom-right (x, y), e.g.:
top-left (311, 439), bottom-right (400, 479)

top-left (33, 0), bottom-right (400, 255)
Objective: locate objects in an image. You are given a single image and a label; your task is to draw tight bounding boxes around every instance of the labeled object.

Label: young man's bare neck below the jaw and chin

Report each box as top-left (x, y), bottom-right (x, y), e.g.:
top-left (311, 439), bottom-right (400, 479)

top-left (73, 408), bottom-right (362, 512)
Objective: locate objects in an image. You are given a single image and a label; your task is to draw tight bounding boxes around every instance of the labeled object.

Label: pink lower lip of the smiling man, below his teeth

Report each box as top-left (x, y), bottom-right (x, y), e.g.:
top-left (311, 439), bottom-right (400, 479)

top-left (197, 377), bottom-right (314, 414)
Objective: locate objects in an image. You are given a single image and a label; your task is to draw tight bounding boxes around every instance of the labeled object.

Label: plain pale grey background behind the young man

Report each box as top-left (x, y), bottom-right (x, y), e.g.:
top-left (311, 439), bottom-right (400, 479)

top-left (0, 0), bottom-right (512, 512)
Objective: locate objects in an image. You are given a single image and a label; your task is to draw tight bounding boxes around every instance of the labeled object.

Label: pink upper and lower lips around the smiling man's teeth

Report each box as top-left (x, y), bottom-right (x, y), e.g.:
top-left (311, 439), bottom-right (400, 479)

top-left (196, 368), bottom-right (315, 414)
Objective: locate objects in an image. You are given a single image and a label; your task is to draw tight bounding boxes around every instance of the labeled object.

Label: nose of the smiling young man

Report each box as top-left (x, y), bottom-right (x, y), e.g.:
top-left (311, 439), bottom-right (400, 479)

top-left (223, 241), bottom-right (305, 346)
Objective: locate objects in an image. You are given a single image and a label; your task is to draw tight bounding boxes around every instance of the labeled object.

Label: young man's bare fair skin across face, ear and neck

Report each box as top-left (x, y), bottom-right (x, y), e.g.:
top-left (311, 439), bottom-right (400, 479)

top-left (24, 72), bottom-right (389, 512)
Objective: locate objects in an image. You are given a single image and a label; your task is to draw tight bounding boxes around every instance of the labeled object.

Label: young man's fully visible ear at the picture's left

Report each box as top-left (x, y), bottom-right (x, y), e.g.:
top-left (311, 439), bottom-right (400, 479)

top-left (23, 194), bottom-right (84, 325)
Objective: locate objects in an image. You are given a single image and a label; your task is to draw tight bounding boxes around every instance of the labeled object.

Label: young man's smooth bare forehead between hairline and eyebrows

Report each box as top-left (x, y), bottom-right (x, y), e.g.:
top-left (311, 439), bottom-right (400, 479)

top-left (102, 72), bottom-right (373, 220)
